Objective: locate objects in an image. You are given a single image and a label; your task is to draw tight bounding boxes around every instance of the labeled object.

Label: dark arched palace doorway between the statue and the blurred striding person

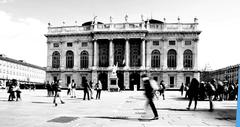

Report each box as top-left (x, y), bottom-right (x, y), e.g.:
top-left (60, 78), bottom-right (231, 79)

top-left (129, 72), bottom-right (140, 90)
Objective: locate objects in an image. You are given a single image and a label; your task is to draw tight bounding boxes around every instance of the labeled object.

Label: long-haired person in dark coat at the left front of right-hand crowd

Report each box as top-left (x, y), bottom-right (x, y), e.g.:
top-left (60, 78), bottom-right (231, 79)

top-left (187, 78), bottom-right (199, 110)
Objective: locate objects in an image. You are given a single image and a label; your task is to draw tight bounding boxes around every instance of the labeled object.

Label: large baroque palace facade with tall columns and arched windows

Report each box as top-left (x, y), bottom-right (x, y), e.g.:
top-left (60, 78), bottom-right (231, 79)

top-left (45, 18), bottom-right (201, 90)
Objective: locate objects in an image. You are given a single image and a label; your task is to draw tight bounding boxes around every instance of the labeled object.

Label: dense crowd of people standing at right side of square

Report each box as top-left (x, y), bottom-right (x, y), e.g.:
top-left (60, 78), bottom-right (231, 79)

top-left (183, 78), bottom-right (238, 111)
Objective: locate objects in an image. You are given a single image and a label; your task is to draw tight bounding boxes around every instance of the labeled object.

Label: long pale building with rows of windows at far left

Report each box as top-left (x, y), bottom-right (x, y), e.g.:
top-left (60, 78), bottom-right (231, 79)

top-left (0, 54), bottom-right (46, 85)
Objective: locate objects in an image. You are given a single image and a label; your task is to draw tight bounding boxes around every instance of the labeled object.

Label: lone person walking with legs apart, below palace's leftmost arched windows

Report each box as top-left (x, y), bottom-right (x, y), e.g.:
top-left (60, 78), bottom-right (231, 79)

top-left (53, 79), bottom-right (65, 106)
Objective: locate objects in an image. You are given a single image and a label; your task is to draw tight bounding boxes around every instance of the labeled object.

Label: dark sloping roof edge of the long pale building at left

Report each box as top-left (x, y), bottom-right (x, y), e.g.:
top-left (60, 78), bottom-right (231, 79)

top-left (0, 55), bottom-right (46, 71)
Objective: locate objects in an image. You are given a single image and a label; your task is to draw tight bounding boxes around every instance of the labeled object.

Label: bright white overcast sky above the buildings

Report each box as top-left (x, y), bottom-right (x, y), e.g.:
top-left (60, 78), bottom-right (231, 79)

top-left (0, 0), bottom-right (240, 69)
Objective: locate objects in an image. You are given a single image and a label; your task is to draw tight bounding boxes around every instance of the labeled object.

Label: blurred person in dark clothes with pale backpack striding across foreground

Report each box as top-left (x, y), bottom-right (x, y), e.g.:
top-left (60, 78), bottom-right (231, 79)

top-left (141, 74), bottom-right (158, 120)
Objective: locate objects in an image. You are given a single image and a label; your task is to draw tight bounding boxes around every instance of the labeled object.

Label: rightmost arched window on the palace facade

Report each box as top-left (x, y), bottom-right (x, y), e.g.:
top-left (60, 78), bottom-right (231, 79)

top-left (183, 49), bottom-right (193, 68)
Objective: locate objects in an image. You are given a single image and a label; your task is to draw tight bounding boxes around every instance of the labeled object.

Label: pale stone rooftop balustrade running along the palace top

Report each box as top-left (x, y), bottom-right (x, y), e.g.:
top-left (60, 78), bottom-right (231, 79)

top-left (48, 23), bottom-right (197, 34)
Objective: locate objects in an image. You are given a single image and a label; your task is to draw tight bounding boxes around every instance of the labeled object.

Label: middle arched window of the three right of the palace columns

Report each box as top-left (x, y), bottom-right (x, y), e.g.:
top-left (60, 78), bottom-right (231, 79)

top-left (167, 49), bottom-right (177, 67)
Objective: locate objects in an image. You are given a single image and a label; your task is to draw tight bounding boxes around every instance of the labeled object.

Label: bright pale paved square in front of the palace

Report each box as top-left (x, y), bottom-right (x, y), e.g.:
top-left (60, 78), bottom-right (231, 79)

top-left (0, 90), bottom-right (237, 127)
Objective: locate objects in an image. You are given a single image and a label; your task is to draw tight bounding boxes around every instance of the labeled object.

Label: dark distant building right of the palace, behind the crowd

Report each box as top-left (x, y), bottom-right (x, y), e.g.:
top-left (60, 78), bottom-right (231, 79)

top-left (201, 64), bottom-right (240, 83)
